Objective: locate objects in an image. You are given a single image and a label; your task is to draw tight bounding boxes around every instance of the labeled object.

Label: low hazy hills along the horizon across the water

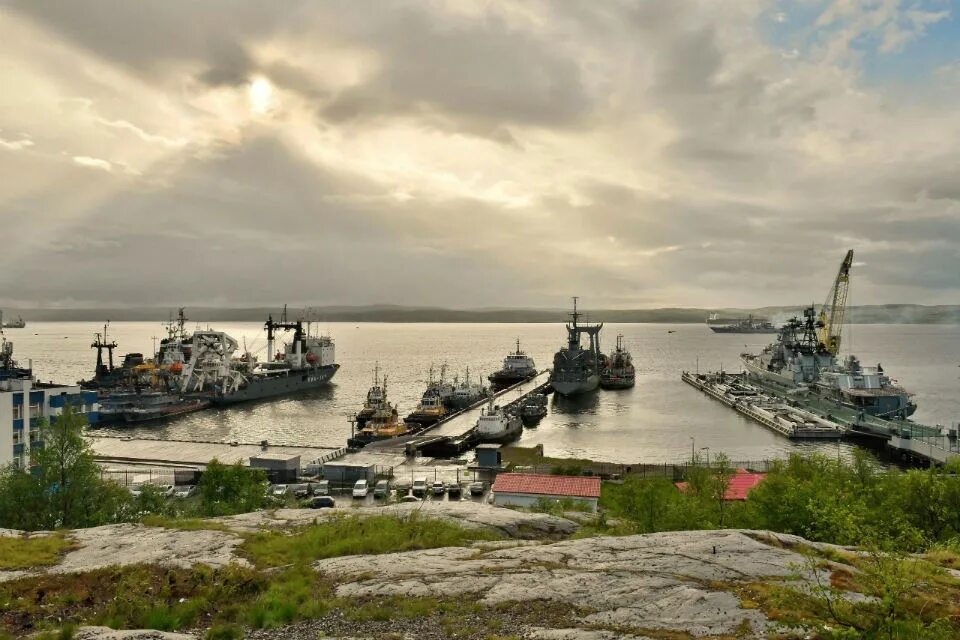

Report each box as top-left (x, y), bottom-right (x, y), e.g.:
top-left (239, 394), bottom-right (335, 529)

top-left (4, 304), bottom-right (960, 324)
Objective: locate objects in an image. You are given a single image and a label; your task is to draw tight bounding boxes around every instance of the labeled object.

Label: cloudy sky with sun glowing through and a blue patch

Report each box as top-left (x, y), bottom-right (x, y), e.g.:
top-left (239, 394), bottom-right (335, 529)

top-left (0, 0), bottom-right (960, 307)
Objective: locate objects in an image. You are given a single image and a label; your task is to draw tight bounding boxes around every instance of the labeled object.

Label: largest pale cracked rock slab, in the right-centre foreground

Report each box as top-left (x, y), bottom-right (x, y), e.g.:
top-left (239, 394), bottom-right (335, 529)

top-left (315, 530), bottom-right (824, 638)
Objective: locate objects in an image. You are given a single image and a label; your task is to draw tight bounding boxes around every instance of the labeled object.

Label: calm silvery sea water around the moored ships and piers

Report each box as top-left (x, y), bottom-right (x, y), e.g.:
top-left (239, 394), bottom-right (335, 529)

top-left (7, 322), bottom-right (960, 463)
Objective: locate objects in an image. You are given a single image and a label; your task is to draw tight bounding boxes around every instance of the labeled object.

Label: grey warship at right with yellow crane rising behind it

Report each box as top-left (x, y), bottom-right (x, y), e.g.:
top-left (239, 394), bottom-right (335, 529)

top-left (741, 250), bottom-right (917, 418)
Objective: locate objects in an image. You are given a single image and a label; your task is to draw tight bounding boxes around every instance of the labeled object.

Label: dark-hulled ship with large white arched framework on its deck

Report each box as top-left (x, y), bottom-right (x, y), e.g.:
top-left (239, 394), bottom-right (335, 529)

top-left (182, 309), bottom-right (340, 406)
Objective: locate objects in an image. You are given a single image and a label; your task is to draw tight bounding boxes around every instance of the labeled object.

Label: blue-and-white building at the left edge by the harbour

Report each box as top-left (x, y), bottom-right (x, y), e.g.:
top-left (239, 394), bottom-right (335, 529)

top-left (0, 338), bottom-right (99, 469)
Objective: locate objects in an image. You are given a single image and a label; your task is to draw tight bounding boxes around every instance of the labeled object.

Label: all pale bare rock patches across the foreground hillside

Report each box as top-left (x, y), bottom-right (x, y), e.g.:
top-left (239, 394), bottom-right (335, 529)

top-left (0, 503), bottom-right (900, 640)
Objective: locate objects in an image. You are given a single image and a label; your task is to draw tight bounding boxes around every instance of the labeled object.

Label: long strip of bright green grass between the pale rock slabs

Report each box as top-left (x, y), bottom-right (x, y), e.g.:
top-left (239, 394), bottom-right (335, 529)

top-left (240, 514), bottom-right (500, 567)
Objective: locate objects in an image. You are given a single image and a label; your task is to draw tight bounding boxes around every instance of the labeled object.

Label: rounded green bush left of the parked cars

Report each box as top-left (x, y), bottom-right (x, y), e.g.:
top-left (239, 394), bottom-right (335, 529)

top-left (198, 458), bottom-right (268, 516)
